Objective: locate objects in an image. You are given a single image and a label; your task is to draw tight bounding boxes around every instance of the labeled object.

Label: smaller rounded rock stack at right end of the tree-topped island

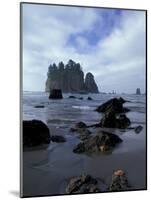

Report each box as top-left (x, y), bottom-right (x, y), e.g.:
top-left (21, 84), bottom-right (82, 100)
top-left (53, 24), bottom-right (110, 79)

top-left (85, 72), bottom-right (99, 93)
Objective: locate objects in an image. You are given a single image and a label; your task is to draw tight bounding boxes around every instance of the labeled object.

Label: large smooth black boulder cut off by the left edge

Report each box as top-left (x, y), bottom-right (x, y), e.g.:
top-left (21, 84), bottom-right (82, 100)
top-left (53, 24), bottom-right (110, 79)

top-left (23, 120), bottom-right (50, 147)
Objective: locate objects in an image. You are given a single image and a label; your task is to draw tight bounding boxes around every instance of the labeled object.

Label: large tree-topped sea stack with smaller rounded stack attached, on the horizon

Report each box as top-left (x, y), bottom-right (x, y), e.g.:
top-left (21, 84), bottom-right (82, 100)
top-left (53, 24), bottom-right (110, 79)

top-left (45, 60), bottom-right (99, 93)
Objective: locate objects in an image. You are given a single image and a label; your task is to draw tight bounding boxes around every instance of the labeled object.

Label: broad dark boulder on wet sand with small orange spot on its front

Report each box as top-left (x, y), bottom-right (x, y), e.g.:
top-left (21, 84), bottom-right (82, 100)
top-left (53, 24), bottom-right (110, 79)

top-left (73, 131), bottom-right (122, 153)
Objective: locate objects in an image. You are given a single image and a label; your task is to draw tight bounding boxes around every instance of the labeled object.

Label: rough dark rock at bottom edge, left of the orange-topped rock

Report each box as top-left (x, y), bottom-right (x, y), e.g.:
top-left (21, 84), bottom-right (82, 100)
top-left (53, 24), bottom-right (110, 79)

top-left (66, 175), bottom-right (100, 194)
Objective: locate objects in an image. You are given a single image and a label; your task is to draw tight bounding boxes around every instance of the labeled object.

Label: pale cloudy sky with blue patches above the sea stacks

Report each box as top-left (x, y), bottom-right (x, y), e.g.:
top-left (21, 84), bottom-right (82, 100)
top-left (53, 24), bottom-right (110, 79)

top-left (22, 4), bottom-right (146, 93)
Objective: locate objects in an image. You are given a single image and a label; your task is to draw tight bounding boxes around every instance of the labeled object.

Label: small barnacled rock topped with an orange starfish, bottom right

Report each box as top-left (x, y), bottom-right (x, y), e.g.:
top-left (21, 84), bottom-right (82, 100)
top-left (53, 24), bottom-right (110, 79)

top-left (109, 170), bottom-right (130, 191)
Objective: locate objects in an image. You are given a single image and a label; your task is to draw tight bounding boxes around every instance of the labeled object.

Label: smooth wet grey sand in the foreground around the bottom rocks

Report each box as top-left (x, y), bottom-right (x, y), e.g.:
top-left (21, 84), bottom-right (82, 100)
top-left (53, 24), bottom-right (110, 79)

top-left (23, 126), bottom-right (146, 196)
